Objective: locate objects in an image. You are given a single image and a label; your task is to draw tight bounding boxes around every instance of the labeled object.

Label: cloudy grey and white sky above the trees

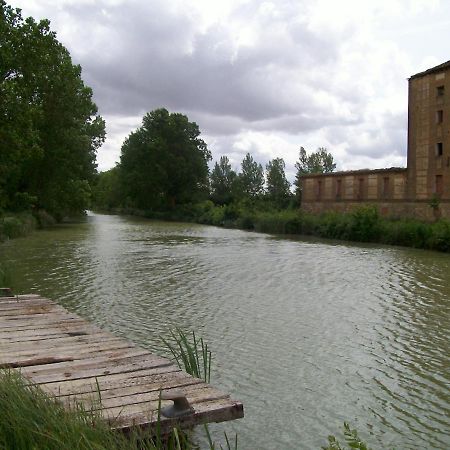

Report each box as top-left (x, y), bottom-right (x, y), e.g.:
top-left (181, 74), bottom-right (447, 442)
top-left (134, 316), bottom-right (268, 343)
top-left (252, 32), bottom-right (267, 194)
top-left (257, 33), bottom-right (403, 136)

top-left (9, 0), bottom-right (450, 181)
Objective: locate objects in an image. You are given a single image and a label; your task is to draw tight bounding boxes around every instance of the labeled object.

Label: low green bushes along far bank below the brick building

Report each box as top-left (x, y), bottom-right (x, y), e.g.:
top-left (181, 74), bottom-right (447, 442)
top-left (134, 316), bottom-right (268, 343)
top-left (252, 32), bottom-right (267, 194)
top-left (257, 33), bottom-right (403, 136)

top-left (100, 201), bottom-right (450, 252)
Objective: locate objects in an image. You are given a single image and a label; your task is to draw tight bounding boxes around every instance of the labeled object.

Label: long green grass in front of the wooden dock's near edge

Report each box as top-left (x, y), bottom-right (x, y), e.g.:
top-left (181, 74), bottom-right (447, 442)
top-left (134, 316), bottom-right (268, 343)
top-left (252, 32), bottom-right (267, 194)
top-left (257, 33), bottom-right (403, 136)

top-left (0, 371), bottom-right (191, 450)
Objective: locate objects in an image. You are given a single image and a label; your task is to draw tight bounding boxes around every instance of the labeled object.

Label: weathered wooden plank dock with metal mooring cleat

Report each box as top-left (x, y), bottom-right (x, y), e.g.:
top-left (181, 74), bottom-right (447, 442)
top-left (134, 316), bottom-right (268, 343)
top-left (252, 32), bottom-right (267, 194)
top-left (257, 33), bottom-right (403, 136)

top-left (0, 295), bottom-right (244, 432)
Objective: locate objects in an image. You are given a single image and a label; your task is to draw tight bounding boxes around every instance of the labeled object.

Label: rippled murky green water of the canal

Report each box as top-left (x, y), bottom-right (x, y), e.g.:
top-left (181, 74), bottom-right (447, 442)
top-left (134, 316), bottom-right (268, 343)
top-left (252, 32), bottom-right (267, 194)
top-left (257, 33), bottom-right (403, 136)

top-left (0, 215), bottom-right (450, 450)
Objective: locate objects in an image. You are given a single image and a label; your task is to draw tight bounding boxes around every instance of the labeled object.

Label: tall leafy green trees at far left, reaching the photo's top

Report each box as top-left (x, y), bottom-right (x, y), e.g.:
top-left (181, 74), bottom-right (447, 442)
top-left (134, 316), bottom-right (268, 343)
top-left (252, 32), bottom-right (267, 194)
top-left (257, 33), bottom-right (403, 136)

top-left (0, 0), bottom-right (105, 218)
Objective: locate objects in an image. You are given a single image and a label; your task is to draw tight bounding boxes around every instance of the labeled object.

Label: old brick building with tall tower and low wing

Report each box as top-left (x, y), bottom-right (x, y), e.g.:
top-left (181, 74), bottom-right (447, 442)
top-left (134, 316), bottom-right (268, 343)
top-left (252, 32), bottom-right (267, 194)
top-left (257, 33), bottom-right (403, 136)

top-left (302, 61), bottom-right (450, 219)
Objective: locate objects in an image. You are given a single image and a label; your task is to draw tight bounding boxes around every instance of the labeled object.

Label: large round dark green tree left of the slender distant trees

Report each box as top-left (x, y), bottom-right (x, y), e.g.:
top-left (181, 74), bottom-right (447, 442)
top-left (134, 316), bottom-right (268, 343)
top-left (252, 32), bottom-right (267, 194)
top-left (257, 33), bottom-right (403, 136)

top-left (119, 108), bottom-right (211, 210)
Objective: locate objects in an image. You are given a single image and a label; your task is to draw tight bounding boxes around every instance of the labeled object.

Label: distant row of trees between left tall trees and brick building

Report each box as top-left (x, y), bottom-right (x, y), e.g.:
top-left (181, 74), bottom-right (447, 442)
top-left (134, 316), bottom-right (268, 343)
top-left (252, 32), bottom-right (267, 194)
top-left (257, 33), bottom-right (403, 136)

top-left (93, 108), bottom-right (336, 217)
